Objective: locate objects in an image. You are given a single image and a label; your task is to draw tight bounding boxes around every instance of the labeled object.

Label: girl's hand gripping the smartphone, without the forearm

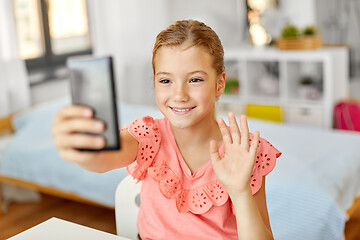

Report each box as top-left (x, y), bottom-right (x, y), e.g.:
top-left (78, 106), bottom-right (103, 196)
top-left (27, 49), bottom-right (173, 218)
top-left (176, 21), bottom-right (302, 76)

top-left (51, 105), bottom-right (105, 164)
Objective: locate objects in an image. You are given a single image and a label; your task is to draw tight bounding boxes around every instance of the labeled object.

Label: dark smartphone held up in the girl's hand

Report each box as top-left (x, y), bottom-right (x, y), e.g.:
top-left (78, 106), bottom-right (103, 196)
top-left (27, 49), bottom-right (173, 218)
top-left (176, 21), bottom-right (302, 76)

top-left (66, 56), bottom-right (121, 151)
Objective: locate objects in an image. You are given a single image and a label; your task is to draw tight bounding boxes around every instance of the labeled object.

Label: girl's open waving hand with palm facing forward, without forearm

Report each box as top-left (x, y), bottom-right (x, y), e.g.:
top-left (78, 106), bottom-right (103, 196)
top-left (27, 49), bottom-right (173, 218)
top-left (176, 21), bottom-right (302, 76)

top-left (210, 113), bottom-right (260, 195)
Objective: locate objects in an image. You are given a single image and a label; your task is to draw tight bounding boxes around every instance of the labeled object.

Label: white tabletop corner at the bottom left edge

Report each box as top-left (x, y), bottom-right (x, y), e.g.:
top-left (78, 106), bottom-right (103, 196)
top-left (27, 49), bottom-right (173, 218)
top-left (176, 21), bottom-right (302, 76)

top-left (8, 217), bottom-right (129, 240)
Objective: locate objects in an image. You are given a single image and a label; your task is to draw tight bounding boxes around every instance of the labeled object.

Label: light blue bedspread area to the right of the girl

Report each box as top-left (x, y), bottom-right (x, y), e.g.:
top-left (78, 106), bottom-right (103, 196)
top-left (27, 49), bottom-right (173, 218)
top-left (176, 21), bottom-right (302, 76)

top-left (249, 121), bottom-right (360, 240)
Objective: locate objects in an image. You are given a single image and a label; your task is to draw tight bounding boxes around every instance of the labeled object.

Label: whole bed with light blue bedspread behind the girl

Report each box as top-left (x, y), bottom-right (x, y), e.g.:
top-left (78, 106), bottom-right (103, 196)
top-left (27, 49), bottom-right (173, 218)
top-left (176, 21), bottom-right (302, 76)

top-left (0, 97), bottom-right (360, 240)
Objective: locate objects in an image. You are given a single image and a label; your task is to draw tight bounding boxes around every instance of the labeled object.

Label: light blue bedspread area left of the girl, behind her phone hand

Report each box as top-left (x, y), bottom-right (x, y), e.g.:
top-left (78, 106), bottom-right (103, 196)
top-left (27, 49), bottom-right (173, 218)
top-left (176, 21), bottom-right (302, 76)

top-left (0, 99), bottom-right (127, 206)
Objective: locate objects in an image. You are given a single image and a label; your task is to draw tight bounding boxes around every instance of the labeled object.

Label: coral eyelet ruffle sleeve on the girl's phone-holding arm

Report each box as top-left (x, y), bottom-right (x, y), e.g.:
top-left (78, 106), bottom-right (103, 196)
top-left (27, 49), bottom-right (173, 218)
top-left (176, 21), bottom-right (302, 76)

top-left (126, 116), bottom-right (161, 181)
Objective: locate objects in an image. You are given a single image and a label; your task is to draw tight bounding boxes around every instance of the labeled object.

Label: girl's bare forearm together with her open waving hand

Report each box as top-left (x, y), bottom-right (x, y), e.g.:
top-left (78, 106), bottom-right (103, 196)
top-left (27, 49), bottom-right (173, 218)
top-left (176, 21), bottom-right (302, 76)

top-left (210, 113), bottom-right (273, 240)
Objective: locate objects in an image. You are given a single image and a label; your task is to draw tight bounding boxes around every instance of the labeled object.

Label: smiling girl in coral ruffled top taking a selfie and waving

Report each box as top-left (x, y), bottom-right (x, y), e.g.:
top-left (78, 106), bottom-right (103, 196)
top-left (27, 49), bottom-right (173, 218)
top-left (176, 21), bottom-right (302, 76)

top-left (52, 20), bottom-right (281, 240)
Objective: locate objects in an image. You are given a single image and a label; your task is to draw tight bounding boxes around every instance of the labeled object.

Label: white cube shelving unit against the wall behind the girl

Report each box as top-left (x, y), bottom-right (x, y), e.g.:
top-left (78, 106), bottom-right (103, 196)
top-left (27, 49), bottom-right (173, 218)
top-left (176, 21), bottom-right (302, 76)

top-left (219, 47), bottom-right (349, 128)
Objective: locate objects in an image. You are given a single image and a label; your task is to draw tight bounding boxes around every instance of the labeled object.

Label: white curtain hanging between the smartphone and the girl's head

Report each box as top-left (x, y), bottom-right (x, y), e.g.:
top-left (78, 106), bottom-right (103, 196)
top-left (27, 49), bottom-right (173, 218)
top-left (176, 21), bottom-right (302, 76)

top-left (87, 0), bottom-right (168, 104)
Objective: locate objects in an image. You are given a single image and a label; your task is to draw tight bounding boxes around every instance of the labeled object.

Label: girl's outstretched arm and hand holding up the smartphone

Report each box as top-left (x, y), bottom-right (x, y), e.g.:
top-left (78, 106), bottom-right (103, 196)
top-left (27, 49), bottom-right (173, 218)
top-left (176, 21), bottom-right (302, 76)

top-left (52, 105), bottom-right (138, 172)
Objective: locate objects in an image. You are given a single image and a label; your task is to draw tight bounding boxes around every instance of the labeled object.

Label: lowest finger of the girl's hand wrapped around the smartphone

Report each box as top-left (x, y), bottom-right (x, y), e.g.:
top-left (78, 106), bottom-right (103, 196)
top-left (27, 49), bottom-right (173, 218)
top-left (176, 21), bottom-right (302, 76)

top-left (55, 133), bottom-right (106, 149)
